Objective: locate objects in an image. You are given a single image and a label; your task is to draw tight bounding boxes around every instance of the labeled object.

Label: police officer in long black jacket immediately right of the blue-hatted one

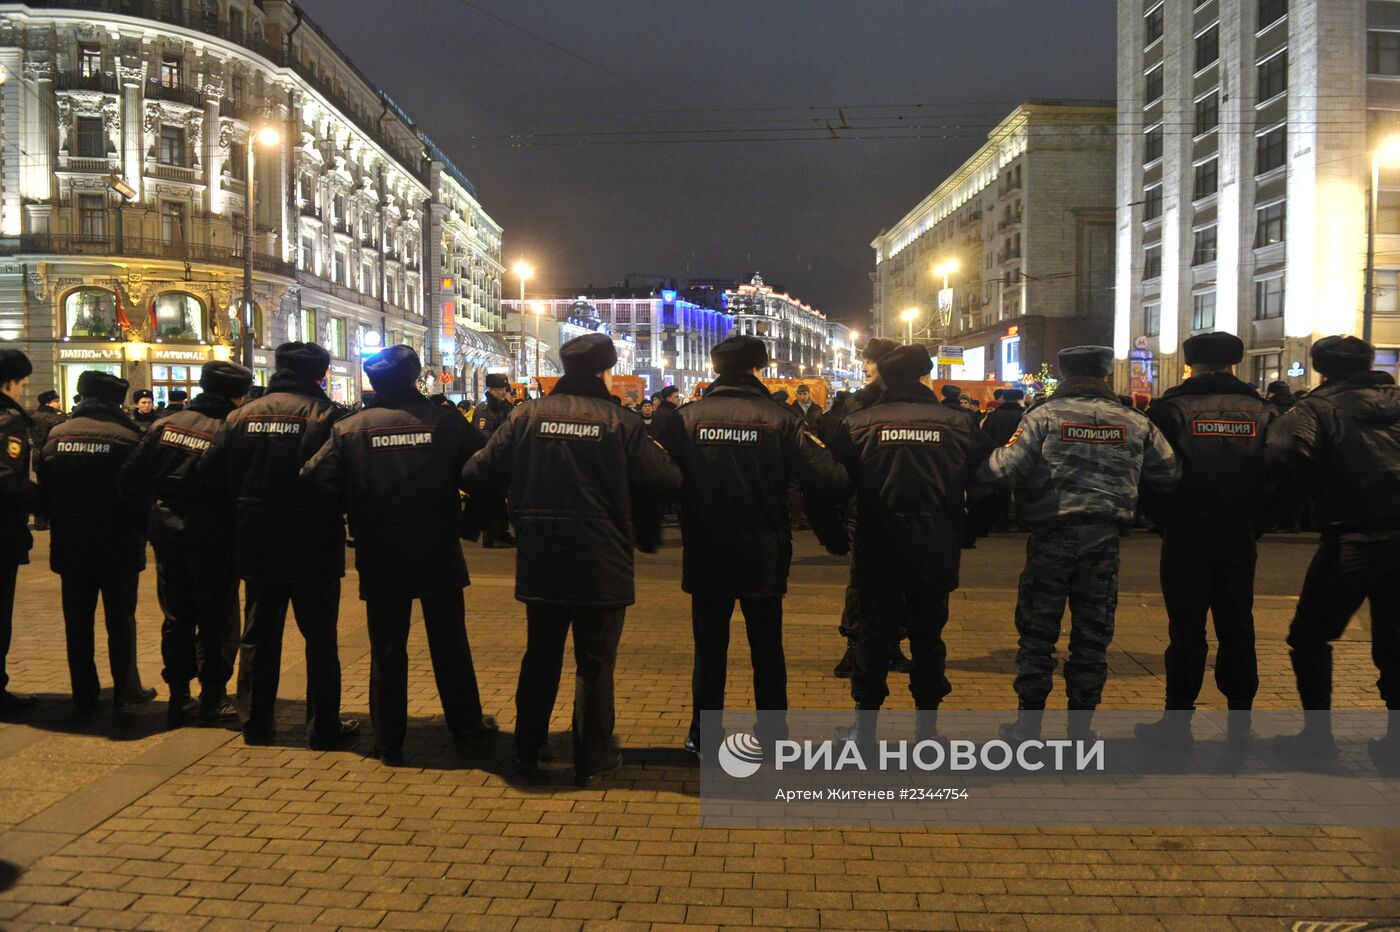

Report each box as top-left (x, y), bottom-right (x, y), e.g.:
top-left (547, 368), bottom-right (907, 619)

top-left (462, 333), bottom-right (680, 785)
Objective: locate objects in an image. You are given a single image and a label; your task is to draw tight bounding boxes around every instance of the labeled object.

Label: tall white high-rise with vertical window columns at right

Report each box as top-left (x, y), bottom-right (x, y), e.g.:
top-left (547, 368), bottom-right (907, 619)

top-left (1113, 0), bottom-right (1400, 393)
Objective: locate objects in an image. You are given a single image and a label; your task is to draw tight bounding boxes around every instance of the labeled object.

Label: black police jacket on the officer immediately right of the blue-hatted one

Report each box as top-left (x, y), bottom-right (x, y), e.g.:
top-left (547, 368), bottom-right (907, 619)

top-left (462, 375), bottom-right (680, 609)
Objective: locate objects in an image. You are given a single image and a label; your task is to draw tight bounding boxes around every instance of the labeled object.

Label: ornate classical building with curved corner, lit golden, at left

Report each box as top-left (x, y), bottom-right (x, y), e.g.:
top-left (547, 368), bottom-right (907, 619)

top-left (0, 0), bottom-right (505, 403)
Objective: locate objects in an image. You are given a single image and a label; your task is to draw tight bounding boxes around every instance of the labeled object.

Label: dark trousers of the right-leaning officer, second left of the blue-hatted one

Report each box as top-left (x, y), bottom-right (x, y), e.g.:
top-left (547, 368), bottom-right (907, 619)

top-left (154, 542), bottom-right (238, 701)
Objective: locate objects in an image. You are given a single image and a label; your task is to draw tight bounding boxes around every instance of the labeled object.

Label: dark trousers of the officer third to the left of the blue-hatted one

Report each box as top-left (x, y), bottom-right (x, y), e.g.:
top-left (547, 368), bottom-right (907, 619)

top-left (62, 571), bottom-right (141, 707)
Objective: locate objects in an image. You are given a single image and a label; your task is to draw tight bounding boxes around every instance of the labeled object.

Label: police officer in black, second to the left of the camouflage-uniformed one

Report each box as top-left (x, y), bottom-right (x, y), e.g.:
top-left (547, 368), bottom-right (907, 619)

top-left (658, 336), bottom-right (850, 756)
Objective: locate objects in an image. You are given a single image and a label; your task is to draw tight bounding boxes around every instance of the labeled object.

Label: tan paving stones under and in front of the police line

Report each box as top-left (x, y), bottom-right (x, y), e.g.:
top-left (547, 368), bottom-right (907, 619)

top-left (0, 532), bottom-right (1400, 931)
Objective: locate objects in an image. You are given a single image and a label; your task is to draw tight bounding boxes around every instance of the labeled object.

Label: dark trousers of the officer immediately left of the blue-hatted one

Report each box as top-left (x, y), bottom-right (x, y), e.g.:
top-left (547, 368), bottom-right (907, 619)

top-left (238, 579), bottom-right (340, 740)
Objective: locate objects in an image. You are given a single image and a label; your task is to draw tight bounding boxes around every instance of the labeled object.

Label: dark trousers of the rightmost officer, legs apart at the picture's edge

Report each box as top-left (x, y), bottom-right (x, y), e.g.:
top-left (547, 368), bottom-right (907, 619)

top-left (1288, 535), bottom-right (1400, 711)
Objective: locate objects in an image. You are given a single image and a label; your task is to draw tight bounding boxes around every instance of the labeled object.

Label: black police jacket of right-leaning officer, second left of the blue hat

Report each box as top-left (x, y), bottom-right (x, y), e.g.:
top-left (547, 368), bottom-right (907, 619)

top-left (122, 393), bottom-right (234, 545)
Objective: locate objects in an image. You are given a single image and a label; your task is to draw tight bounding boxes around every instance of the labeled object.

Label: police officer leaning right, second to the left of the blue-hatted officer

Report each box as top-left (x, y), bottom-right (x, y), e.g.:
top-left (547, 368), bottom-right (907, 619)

top-left (122, 360), bottom-right (253, 728)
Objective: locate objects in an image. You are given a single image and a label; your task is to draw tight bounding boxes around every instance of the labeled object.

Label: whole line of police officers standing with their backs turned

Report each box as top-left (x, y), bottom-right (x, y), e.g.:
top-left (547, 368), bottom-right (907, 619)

top-left (0, 323), bottom-right (1400, 785)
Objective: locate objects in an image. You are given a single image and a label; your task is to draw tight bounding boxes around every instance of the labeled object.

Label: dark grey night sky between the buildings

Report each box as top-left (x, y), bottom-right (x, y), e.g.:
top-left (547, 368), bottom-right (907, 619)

top-left (300, 0), bottom-right (1114, 320)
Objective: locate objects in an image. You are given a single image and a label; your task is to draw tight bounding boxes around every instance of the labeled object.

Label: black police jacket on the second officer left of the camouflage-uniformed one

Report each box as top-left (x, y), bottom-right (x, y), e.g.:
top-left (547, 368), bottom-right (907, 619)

top-left (658, 376), bottom-right (850, 598)
